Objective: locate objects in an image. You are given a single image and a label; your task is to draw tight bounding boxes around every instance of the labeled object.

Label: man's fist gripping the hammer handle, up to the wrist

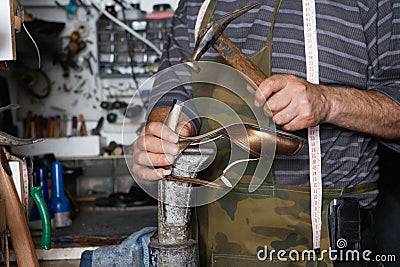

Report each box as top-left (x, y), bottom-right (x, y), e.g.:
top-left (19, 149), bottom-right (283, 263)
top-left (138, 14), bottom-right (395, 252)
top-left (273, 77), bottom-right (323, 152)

top-left (255, 74), bottom-right (331, 131)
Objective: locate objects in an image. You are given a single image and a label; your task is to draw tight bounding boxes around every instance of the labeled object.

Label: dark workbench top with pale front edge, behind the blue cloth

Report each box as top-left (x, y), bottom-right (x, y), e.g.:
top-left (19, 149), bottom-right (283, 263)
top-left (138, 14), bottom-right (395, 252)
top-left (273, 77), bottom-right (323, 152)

top-left (10, 203), bottom-right (157, 267)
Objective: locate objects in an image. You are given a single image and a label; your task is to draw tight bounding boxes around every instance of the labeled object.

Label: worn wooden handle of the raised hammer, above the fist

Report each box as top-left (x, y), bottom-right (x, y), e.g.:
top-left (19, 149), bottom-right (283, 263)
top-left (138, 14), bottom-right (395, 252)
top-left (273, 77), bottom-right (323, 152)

top-left (213, 34), bottom-right (267, 86)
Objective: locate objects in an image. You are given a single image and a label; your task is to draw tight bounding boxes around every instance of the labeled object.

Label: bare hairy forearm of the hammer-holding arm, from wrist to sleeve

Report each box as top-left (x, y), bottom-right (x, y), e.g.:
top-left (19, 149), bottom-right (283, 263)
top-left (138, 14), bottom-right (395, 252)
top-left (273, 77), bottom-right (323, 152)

top-left (323, 87), bottom-right (400, 139)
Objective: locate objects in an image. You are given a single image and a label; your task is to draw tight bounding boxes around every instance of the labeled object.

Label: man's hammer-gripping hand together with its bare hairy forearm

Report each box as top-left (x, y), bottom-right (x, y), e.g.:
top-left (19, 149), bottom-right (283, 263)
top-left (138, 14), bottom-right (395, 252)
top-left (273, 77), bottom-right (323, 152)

top-left (252, 74), bottom-right (400, 139)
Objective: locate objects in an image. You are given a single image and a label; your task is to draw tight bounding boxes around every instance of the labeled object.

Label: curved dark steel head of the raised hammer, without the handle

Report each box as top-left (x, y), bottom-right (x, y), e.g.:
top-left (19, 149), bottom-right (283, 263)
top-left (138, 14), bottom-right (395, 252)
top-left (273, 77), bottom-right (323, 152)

top-left (189, 3), bottom-right (258, 61)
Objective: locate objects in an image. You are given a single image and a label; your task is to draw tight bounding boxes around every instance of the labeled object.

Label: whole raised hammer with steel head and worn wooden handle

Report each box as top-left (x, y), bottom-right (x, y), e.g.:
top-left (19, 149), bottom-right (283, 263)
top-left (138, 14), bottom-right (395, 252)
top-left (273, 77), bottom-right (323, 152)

top-left (182, 3), bottom-right (270, 86)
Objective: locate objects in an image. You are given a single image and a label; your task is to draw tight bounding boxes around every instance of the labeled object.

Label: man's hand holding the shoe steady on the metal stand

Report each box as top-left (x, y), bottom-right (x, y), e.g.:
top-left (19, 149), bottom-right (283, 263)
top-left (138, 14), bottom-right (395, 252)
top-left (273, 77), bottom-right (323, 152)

top-left (133, 109), bottom-right (192, 180)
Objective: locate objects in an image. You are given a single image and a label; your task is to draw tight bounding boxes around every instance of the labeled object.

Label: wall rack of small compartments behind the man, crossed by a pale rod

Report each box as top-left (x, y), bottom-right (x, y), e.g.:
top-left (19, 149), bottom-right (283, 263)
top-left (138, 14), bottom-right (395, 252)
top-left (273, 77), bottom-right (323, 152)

top-left (96, 16), bottom-right (171, 78)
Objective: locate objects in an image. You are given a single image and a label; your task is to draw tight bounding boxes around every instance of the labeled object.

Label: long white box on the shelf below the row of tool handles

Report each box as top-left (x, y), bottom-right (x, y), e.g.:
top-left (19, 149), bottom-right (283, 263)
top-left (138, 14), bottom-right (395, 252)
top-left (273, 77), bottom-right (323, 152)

top-left (11, 135), bottom-right (105, 157)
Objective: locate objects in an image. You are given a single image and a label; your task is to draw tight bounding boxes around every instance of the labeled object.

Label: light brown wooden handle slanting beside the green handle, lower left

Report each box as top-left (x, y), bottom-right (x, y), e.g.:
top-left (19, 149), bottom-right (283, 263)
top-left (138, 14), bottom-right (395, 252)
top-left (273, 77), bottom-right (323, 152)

top-left (0, 150), bottom-right (39, 267)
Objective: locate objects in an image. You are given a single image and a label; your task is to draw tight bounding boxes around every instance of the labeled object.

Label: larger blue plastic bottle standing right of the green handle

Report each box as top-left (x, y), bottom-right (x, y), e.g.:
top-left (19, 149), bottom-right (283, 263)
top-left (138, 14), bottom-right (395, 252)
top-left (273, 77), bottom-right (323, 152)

top-left (51, 161), bottom-right (72, 227)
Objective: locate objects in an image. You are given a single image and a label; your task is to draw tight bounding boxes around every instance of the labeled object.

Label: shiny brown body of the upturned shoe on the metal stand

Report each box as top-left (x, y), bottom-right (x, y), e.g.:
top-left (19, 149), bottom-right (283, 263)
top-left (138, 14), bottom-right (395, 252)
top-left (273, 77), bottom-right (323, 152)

top-left (179, 123), bottom-right (306, 157)
